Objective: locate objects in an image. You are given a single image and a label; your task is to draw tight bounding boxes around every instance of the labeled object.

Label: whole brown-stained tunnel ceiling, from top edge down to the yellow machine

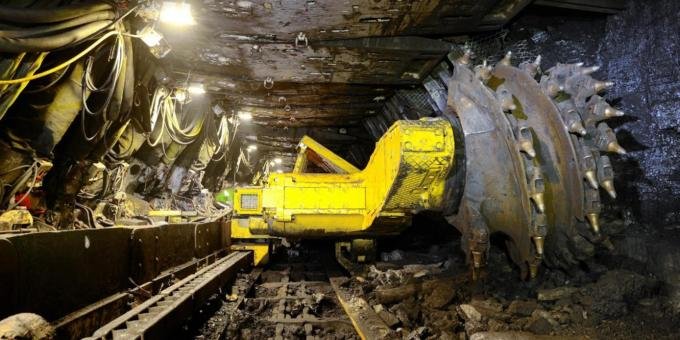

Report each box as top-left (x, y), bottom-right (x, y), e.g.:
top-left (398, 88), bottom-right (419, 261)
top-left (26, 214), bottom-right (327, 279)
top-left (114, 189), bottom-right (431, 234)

top-left (151, 0), bottom-right (624, 170)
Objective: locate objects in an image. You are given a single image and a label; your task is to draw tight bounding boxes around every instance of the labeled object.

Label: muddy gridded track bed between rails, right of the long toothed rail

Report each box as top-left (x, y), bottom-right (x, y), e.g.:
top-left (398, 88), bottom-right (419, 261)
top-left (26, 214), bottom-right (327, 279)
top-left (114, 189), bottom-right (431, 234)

top-left (194, 246), bottom-right (390, 340)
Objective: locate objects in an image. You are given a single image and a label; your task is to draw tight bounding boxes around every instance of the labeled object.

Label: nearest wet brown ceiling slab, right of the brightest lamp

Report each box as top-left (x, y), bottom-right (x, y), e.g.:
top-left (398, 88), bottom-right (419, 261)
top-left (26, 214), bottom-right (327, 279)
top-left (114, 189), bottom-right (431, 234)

top-left (165, 0), bottom-right (528, 84)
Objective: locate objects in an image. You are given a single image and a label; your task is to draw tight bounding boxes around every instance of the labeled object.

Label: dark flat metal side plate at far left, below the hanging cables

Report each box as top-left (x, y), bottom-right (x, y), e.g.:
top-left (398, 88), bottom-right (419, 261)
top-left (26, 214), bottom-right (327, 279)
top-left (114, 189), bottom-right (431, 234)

top-left (2, 228), bottom-right (130, 320)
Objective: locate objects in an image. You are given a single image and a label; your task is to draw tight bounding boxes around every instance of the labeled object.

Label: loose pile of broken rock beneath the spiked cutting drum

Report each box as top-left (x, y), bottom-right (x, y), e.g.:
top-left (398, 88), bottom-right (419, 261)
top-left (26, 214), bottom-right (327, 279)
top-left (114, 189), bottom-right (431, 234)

top-left (350, 235), bottom-right (680, 339)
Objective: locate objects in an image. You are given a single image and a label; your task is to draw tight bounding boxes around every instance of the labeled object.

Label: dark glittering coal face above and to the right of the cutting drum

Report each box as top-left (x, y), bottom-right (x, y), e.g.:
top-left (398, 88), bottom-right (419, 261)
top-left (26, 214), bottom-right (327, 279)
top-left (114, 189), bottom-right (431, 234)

top-left (503, 0), bottom-right (680, 225)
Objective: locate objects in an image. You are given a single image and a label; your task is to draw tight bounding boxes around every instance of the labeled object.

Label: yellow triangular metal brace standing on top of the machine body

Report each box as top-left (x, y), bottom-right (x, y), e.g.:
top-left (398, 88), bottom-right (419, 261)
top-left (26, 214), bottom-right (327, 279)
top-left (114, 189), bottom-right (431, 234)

top-left (293, 136), bottom-right (359, 174)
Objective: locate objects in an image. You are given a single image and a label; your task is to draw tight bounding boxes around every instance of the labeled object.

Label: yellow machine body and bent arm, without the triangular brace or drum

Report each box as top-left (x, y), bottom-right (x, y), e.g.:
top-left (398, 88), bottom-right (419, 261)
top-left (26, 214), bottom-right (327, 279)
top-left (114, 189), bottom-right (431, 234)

top-left (234, 119), bottom-right (454, 237)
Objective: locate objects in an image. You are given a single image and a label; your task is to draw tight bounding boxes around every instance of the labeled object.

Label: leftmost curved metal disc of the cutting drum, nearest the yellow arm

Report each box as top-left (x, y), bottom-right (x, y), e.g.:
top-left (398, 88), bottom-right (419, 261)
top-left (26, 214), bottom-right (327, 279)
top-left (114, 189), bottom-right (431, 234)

top-left (447, 57), bottom-right (531, 270)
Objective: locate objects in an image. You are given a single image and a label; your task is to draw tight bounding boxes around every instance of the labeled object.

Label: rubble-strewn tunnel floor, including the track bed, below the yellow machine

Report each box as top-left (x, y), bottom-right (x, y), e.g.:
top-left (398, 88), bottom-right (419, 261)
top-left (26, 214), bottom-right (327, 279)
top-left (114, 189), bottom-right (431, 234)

top-left (177, 218), bottom-right (680, 339)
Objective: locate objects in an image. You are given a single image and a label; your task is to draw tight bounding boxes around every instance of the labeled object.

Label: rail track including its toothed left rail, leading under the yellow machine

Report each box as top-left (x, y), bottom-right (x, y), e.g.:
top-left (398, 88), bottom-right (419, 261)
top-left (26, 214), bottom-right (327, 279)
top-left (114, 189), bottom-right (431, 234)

top-left (81, 244), bottom-right (390, 340)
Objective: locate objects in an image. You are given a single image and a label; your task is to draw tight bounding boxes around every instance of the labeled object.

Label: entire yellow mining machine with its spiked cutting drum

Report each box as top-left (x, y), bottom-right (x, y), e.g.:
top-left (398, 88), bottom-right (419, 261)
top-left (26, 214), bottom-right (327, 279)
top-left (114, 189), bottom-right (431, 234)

top-left (232, 54), bottom-right (625, 277)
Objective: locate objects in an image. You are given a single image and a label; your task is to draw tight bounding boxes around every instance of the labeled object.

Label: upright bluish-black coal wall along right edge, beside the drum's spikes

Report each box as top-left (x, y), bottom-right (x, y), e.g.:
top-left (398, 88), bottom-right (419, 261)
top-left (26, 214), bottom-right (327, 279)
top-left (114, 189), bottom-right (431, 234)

top-left (599, 0), bottom-right (680, 223)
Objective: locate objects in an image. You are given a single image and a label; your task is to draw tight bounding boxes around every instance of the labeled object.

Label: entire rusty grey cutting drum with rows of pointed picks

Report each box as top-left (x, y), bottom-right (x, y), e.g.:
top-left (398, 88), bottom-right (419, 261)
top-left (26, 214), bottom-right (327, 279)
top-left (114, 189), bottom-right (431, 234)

top-left (446, 52), bottom-right (625, 278)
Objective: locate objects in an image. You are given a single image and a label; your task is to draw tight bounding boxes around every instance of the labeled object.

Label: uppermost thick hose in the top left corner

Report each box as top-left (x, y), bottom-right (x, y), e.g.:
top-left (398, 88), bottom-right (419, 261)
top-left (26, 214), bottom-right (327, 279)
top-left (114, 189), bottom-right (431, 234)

top-left (0, 3), bottom-right (113, 25)
